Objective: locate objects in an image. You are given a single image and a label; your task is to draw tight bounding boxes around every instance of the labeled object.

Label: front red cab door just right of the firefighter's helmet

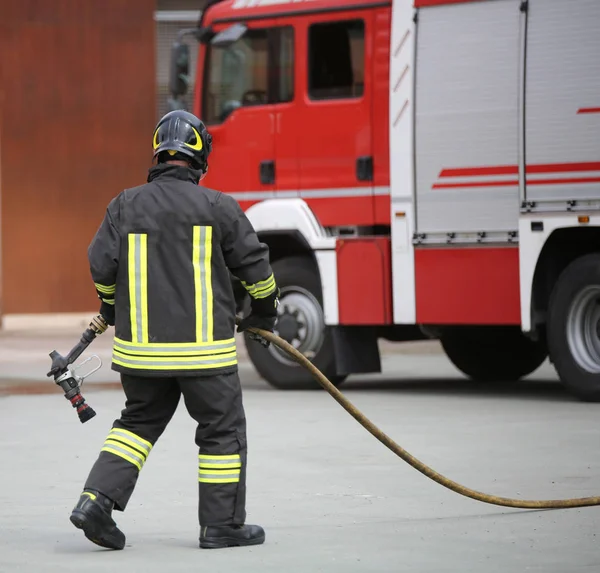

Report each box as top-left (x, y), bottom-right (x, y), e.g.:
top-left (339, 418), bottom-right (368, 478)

top-left (200, 19), bottom-right (290, 208)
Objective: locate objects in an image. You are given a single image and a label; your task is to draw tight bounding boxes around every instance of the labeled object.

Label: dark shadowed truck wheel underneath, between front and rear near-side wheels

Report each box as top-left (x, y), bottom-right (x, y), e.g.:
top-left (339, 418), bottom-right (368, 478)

top-left (440, 326), bottom-right (548, 382)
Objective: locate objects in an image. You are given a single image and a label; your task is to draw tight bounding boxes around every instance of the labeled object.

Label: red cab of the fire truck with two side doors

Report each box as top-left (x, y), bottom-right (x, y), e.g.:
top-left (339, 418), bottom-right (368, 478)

top-left (193, 0), bottom-right (390, 227)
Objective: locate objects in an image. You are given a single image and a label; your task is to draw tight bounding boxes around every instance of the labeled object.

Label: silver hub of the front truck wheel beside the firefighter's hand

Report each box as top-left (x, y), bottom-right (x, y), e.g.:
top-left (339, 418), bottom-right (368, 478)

top-left (269, 286), bottom-right (325, 366)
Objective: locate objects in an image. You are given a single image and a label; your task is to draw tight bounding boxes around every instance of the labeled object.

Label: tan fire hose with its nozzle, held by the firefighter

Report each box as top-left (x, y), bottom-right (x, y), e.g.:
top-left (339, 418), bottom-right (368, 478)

top-left (48, 316), bottom-right (600, 509)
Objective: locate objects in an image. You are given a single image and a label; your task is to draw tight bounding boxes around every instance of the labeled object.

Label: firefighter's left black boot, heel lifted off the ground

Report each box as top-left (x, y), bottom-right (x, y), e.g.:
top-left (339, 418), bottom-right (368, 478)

top-left (71, 490), bottom-right (125, 549)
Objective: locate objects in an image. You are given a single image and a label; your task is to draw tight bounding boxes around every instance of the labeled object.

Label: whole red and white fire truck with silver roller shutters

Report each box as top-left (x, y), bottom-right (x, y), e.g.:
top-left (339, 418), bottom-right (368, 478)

top-left (170, 0), bottom-right (600, 401)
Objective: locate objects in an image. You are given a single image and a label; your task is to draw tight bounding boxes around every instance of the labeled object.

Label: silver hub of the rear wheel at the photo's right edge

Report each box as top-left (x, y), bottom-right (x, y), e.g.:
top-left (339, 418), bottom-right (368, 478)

top-left (567, 285), bottom-right (600, 374)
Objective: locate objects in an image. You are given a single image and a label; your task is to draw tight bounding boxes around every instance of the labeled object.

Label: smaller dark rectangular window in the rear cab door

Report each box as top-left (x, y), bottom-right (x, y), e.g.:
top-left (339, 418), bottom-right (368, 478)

top-left (308, 20), bottom-right (365, 99)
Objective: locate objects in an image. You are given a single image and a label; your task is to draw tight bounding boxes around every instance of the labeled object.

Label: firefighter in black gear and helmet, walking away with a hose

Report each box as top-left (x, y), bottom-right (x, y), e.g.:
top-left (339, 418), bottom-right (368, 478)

top-left (71, 111), bottom-right (279, 549)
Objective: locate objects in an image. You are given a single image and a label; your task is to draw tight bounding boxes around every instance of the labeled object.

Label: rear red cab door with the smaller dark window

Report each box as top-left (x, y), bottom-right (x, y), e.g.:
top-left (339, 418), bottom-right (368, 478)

top-left (292, 10), bottom-right (374, 226)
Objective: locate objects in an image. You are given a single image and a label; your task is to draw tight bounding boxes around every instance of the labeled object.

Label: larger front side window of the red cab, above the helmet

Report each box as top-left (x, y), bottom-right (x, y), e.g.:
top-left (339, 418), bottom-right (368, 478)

top-left (202, 27), bottom-right (294, 124)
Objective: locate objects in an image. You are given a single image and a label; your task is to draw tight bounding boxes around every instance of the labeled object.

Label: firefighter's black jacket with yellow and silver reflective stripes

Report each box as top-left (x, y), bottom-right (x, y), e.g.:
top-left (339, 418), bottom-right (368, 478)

top-left (88, 164), bottom-right (277, 376)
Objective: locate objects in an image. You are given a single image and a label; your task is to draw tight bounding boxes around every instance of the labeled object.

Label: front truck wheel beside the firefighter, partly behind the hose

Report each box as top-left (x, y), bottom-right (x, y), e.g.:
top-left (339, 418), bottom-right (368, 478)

top-left (245, 256), bottom-right (345, 390)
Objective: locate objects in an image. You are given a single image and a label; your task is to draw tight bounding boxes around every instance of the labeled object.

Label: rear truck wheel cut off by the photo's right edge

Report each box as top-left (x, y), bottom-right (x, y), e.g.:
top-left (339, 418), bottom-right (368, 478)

top-left (547, 254), bottom-right (600, 402)
